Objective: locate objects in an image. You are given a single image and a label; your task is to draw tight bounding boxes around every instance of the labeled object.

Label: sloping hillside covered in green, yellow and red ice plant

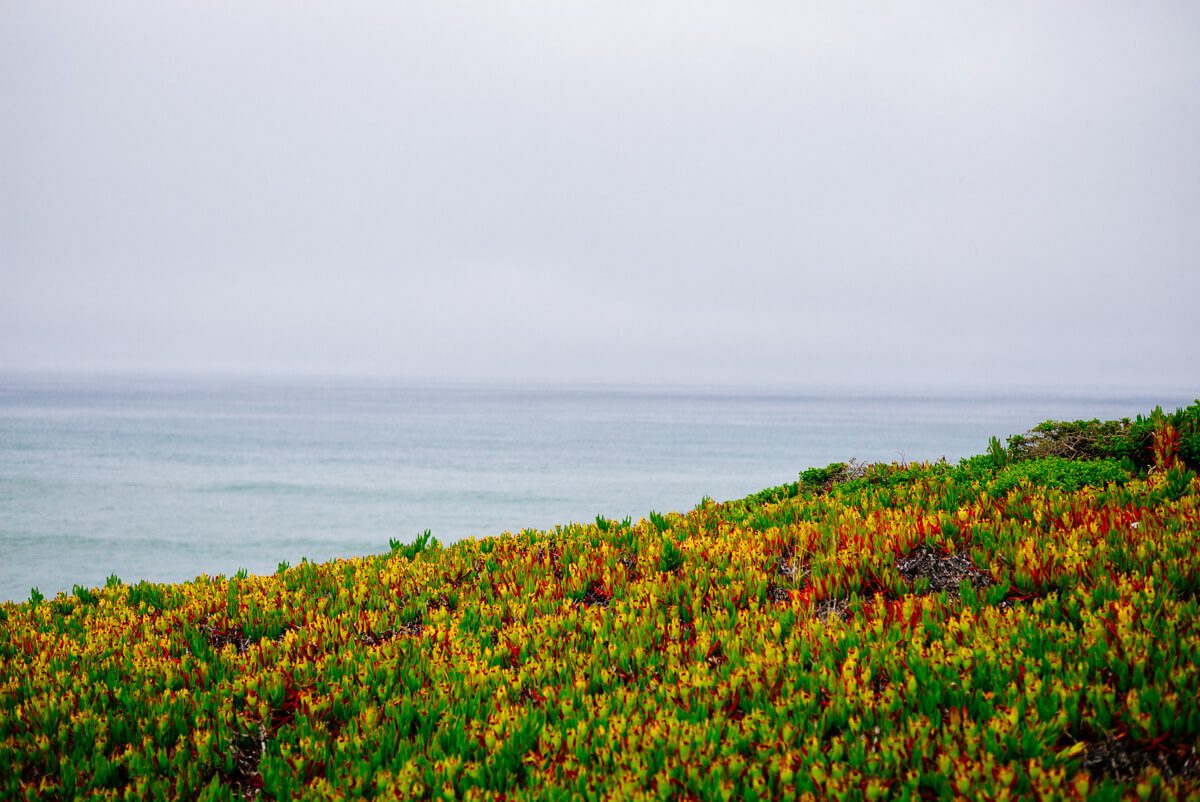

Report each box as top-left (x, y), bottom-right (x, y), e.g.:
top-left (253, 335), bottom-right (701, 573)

top-left (0, 403), bottom-right (1200, 800)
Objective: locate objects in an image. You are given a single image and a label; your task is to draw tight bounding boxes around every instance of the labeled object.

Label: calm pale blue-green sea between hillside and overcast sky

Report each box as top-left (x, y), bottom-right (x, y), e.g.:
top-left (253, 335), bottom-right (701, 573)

top-left (0, 376), bottom-right (1190, 600)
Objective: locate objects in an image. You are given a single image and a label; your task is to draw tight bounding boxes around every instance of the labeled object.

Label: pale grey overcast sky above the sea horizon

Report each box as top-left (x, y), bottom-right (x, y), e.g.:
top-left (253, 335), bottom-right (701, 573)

top-left (0, 0), bottom-right (1200, 389)
